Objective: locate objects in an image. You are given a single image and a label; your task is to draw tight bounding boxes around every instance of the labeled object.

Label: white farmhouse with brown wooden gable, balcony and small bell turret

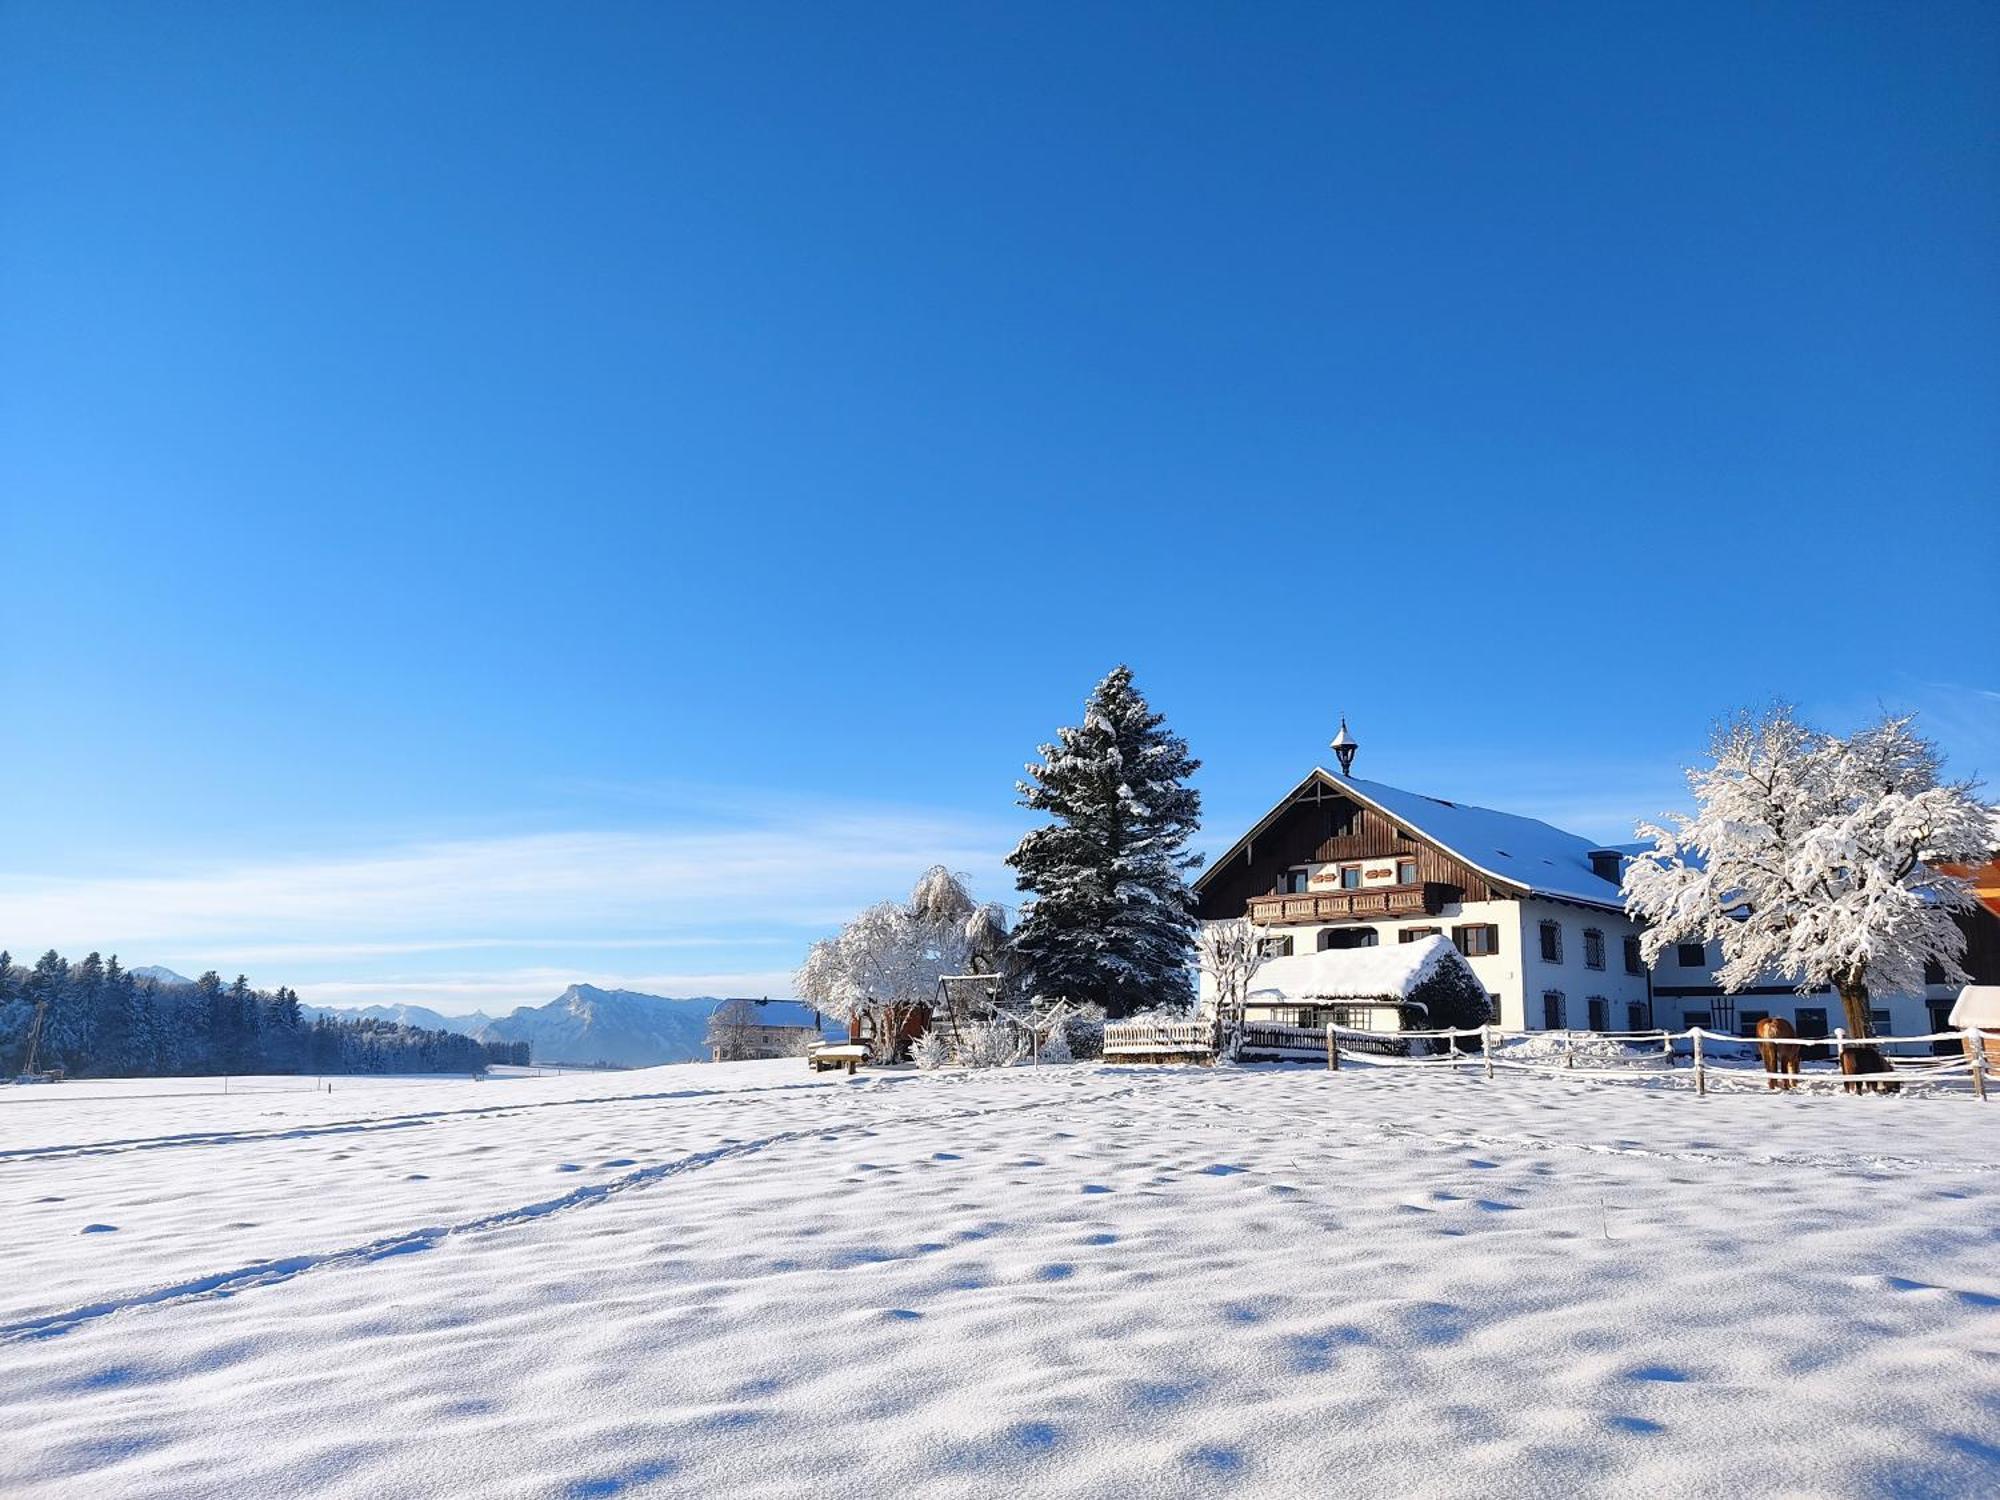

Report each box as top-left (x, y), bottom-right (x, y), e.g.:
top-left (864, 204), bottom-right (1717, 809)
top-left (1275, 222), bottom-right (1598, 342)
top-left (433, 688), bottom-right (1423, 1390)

top-left (1194, 724), bottom-right (1652, 1030)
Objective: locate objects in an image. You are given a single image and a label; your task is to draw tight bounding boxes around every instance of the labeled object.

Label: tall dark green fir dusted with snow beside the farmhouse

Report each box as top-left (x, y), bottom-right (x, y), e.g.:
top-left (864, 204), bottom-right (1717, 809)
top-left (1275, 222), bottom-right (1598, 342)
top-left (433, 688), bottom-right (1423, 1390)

top-left (1008, 666), bottom-right (1202, 1016)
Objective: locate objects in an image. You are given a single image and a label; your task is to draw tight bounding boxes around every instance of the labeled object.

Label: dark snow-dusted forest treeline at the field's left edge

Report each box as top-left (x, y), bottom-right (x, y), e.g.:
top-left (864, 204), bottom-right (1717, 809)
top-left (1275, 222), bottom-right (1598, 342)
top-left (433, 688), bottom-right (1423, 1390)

top-left (0, 950), bottom-right (508, 1078)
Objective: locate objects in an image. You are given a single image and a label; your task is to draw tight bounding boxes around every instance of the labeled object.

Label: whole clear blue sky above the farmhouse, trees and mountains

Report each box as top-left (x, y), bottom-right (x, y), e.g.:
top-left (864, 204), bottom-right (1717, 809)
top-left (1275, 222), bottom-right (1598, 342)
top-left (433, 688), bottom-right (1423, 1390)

top-left (0, 0), bottom-right (2000, 1010)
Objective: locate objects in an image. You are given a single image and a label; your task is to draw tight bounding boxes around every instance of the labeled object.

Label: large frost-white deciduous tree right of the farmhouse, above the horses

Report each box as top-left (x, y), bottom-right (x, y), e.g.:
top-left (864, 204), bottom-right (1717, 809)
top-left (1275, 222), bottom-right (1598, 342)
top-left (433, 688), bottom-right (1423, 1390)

top-left (1624, 708), bottom-right (1992, 1036)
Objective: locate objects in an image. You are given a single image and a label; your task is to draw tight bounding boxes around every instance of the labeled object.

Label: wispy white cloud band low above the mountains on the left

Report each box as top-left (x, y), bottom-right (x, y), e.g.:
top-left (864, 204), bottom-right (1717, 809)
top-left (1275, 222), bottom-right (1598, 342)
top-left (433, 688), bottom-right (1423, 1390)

top-left (0, 798), bottom-right (1012, 1010)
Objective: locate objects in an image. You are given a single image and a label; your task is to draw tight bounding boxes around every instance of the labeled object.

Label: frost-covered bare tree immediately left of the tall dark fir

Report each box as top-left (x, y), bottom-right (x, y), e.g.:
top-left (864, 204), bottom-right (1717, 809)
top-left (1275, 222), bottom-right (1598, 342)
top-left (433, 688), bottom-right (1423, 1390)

top-left (794, 864), bottom-right (998, 1062)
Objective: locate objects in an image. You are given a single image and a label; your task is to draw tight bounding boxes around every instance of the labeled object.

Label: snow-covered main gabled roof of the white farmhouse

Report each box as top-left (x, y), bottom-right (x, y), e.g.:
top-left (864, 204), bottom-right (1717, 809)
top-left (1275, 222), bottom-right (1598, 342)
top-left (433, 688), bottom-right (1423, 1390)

top-left (1198, 766), bottom-right (1628, 910)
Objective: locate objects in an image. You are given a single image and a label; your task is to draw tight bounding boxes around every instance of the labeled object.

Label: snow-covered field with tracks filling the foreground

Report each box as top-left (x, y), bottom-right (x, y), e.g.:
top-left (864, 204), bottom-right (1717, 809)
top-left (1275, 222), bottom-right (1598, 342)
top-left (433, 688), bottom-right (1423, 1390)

top-left (0, 1062), bottom-right (2000, 1500)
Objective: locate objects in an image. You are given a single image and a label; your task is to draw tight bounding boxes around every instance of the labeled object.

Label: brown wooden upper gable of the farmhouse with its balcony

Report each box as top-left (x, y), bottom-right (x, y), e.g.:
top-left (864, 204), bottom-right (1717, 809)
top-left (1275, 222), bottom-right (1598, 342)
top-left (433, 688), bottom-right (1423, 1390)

top-left (1196, 776), bottom-right (1520, 926)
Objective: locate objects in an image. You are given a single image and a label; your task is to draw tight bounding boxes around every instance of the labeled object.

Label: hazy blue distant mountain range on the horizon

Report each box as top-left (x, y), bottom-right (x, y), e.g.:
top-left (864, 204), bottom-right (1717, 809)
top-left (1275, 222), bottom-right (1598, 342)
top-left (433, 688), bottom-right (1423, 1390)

top-left (132, 964), bottom-right (824, 1068)
